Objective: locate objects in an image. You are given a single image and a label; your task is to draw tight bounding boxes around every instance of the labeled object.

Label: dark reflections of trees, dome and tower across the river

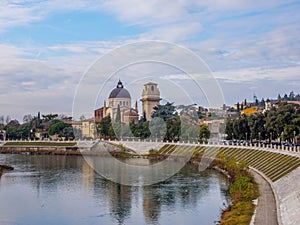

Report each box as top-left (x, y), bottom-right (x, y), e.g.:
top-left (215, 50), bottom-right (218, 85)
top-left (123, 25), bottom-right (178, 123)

top-left (5, 155), bottom-right (228, 224)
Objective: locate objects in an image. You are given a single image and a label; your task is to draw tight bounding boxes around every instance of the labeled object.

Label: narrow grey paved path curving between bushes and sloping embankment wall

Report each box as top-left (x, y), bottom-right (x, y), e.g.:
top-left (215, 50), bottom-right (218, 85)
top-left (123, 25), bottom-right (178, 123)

top-left (252, 172), bottom-right (278, 225)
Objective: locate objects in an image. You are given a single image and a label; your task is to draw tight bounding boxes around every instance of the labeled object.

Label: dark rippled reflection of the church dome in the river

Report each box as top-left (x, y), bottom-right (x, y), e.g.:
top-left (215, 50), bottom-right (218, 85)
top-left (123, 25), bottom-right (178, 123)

top-left (109, 182), bottom-right (131, 224)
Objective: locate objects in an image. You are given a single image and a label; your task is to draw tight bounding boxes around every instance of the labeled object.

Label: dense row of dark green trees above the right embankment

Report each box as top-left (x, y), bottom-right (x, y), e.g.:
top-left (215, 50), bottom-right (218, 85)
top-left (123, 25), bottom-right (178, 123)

top-left (225, 102), bottom-right (300, 142)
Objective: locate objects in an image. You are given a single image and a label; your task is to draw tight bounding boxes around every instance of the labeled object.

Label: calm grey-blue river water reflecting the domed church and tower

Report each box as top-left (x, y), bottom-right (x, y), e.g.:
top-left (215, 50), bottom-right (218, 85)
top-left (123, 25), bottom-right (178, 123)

top-left (0, 155), bottom-right (228, 225)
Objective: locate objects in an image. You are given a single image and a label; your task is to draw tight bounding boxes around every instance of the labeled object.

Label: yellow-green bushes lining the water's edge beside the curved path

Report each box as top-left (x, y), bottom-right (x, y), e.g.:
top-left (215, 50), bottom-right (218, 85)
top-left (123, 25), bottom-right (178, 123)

top-left (212, 154), bottom-right (259, 225)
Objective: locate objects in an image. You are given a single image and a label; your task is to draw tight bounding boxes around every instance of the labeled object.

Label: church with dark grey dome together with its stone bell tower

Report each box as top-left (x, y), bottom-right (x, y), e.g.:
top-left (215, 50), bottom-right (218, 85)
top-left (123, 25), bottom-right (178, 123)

top-left (94, 80), bottom-right (161, 124)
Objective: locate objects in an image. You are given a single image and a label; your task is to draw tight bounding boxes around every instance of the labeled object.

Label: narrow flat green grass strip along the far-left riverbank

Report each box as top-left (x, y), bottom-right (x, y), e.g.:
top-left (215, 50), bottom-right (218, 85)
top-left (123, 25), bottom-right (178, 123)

top-left (4, 141), bottom-right (76, 147)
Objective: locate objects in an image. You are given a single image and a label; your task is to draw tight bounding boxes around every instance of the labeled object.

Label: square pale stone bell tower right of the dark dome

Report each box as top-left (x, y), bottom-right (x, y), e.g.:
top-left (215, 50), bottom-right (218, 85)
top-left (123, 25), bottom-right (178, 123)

top-left (141, 82), bottom-right (161, 121)
